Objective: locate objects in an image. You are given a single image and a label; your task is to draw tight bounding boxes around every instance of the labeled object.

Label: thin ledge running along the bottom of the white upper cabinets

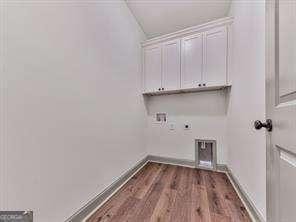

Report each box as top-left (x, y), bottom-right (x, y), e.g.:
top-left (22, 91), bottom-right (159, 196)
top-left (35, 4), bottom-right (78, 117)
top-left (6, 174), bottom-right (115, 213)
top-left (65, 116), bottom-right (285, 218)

top-left (143, 85), bottom-right (231, 96)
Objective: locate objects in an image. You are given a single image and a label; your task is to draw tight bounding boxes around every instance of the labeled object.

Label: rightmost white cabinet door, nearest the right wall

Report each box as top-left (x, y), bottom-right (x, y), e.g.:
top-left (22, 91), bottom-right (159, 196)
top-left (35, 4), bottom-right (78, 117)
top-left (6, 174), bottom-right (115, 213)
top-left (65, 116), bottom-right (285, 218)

top-left (203, 27), bottom-right (228, 86)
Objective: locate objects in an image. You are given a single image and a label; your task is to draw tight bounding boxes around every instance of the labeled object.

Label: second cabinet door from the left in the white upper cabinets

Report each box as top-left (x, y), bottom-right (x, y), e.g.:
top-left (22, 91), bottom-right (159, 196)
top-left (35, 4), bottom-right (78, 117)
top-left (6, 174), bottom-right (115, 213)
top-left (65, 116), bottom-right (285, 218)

top-left (162, 39), bottom-right (181, 90)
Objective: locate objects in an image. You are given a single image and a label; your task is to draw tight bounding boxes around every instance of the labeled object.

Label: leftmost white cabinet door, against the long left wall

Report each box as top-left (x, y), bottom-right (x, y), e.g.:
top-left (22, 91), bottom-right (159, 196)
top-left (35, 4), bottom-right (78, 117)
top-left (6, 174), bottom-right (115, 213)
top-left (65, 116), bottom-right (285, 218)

top-left (143, 45), bottom-right (161, 92)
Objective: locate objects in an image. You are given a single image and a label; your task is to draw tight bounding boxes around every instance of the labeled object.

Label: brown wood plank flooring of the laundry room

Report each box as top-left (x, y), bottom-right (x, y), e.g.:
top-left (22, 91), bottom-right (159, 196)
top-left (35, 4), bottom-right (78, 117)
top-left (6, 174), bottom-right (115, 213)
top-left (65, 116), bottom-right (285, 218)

top-left (87, 163), bottom-right (251, 222)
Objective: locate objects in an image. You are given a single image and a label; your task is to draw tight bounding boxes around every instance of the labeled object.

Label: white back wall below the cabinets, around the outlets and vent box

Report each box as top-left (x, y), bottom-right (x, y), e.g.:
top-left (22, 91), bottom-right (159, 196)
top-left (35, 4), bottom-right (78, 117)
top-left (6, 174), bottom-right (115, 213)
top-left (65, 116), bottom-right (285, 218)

top-left (146, 91), bottom-right (227, 163)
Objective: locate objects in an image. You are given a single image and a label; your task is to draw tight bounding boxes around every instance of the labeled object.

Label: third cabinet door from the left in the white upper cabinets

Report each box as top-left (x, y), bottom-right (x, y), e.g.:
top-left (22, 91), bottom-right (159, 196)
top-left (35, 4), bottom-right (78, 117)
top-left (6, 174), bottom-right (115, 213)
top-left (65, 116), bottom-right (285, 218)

top-left (181, 34), bottom-right (203, 88)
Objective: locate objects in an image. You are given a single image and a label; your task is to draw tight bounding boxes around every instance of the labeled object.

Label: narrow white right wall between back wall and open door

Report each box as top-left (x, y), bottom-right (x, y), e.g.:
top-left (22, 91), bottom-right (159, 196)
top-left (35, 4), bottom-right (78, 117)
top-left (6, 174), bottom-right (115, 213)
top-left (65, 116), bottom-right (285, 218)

top-left (227, 0), bottom-right (266, 218)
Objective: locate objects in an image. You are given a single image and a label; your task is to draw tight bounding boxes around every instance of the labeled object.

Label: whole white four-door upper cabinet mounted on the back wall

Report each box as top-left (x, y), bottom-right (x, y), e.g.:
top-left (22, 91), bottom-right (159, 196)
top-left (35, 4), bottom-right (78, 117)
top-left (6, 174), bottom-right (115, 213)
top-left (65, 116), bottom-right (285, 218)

top-left (143, 17), bottom-right (233, 95)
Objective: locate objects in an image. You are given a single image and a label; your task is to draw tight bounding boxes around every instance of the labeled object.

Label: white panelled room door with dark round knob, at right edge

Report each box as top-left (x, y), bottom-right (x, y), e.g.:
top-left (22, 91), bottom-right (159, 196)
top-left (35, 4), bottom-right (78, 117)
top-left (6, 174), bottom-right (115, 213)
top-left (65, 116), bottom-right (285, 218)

top-left (266, 0), bottom-right (296, 222)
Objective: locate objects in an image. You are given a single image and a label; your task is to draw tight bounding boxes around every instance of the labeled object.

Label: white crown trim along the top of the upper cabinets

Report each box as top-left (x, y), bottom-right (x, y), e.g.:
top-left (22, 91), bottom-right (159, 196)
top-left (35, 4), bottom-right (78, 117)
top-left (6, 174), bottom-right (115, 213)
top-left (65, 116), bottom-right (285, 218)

top-left (142, 16), bottom-right (234, 47)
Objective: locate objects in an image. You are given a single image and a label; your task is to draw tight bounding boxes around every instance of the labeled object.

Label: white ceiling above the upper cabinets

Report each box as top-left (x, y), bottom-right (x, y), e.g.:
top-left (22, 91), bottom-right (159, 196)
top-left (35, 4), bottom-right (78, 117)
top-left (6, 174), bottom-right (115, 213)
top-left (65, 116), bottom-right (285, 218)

top-left (126, 0), bottom-right (231, 38)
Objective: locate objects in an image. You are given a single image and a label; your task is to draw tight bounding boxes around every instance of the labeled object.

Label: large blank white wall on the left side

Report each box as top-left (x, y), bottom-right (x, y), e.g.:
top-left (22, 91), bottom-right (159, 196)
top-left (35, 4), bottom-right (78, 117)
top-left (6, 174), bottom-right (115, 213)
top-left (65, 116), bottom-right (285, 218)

top-left (0, 0), bottom-right (146, 222)
